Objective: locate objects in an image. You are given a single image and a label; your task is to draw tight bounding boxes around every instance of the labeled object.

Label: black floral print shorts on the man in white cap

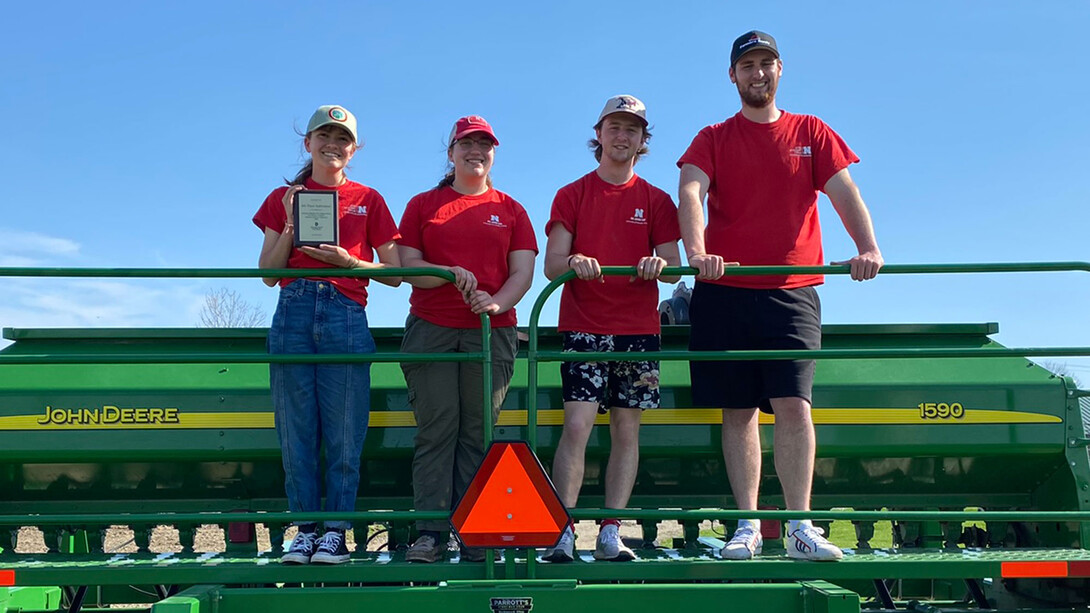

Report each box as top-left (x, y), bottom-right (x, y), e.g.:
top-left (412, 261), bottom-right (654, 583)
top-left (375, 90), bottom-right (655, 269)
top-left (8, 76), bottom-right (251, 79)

top-left (560, 332), bottom-right (661, 413)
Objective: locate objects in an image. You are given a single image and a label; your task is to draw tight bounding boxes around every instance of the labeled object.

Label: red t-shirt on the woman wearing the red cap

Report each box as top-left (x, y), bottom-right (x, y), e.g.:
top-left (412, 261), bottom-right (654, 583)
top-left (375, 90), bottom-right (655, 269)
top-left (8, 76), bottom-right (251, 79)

top-left (400, 188), bottom-right (537, 328)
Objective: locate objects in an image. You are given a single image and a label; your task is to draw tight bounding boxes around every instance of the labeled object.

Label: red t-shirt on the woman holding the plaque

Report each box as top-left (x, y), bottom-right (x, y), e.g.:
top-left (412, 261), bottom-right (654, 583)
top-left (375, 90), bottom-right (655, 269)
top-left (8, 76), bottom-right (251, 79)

top-left (254, 179), bottom-right (401, 307)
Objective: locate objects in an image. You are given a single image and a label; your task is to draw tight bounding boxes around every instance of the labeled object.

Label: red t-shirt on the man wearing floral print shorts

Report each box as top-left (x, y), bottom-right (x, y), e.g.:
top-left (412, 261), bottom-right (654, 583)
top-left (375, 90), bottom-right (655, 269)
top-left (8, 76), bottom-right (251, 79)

top-left (545, 171), bottom-right (681, 334)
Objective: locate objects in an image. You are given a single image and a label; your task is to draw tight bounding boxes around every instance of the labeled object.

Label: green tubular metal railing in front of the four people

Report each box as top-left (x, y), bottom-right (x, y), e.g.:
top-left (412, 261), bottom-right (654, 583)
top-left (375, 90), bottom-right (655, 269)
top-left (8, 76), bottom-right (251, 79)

top-left (0, 262), bottom-right (1090, 578)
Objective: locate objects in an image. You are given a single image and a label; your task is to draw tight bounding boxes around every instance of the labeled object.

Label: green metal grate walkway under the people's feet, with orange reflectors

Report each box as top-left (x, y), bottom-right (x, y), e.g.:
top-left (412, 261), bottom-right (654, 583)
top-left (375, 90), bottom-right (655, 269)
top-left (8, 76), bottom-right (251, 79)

top-left (0, 549), bottom-right (1090, 586)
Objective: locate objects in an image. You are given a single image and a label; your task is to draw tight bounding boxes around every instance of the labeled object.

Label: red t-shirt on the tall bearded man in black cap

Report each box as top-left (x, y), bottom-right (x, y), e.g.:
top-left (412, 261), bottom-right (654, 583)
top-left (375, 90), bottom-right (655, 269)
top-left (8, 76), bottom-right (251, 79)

top-left (678, 111), bottom-right (859, 289)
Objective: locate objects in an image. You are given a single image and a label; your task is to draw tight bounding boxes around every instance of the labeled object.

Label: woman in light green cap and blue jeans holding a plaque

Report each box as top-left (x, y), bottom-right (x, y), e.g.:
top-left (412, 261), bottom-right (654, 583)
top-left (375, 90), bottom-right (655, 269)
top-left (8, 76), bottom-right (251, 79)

top-left (254, 106), bottom-right (400, 564)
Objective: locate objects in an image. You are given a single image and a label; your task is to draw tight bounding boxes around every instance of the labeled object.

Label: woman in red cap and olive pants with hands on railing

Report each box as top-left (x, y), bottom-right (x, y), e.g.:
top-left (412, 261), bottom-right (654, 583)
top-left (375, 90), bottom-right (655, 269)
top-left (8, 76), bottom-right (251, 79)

top-left (398, 116), bottom-right (537, 562)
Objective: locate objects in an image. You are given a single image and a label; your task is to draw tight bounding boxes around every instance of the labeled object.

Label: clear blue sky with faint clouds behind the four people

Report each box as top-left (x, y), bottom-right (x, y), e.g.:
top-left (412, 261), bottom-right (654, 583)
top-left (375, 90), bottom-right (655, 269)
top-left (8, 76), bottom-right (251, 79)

top-left (0, 0), bottom-right (1090, 378)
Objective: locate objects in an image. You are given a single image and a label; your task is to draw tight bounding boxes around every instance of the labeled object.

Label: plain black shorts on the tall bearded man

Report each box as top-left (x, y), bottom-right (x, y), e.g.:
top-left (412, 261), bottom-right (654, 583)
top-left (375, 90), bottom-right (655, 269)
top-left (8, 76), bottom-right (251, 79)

top-left (689, 281), bottom-right (821, 412)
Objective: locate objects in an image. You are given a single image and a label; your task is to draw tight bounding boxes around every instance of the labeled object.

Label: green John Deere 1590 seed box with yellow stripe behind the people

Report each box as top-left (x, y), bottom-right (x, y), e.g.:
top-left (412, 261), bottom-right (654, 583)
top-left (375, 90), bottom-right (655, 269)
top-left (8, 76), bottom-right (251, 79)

top-left (0, 324), bottom-right (1064, 510)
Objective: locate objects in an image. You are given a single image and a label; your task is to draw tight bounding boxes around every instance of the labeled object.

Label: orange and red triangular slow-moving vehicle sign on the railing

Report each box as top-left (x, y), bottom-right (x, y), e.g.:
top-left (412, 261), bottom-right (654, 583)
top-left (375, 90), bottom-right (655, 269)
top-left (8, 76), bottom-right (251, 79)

top-left (450, 441), bottom-right (571, 548)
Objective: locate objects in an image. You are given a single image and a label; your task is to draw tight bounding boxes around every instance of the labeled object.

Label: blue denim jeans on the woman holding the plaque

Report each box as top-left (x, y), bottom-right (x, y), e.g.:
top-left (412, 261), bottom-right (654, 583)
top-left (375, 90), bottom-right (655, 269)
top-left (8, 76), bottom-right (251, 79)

top-left (268, 279), bottom-right (375, 530)
